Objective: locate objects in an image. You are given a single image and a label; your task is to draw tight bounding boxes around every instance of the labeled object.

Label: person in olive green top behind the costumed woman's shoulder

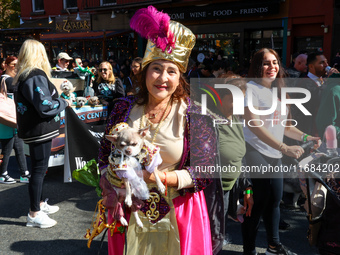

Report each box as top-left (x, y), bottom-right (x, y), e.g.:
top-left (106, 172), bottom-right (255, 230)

top-left (208, 77), bottom-right (254, 254)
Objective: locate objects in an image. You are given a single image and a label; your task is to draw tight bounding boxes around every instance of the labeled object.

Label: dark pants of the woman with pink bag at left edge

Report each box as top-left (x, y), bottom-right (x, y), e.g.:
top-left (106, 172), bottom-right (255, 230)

top-left (0, 134), bottom-right (27, 175)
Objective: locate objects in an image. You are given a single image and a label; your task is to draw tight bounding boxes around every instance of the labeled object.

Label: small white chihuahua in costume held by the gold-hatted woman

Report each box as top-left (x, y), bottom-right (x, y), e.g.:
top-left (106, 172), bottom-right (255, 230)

top-left (105, 123), bottom-right (165, 228)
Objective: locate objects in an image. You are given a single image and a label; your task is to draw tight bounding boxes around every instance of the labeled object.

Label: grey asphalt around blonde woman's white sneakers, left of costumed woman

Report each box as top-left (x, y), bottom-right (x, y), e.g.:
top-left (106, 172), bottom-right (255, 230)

top-left (0, 157), bottom-right (107, 255)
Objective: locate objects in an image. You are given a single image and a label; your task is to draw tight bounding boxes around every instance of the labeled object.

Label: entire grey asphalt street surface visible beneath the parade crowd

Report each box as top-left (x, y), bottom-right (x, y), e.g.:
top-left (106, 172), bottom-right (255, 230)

top-left (0, 156), bottom-right (317, 255)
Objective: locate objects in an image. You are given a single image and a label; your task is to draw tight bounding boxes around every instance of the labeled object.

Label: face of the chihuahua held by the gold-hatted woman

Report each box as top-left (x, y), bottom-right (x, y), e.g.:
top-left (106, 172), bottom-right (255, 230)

top-left (105, 127), bottom-right (149, 156)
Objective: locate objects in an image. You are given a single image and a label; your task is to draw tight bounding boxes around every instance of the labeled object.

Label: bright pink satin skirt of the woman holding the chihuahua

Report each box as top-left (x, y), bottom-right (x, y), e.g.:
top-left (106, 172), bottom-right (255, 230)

top-left (108, 191), bottom-right (212, 255)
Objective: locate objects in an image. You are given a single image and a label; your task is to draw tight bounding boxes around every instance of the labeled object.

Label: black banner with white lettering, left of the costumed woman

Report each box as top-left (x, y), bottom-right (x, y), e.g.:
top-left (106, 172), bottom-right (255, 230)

top-left (64, 107), bottom-right (107, 182)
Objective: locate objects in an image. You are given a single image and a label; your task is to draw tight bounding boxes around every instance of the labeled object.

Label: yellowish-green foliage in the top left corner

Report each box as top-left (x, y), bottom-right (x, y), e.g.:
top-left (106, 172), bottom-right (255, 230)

top-left (0, 0), bottom-right (20, 29)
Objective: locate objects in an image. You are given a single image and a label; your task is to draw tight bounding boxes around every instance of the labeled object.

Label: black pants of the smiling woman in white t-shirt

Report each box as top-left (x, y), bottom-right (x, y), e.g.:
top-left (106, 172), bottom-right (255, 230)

top-left (242, 144), bottom-right (283, 254)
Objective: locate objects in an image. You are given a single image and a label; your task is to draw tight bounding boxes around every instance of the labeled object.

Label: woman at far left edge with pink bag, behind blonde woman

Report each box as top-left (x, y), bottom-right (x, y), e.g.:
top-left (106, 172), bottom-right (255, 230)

top-left (0, 56), bottom-right (29, 184)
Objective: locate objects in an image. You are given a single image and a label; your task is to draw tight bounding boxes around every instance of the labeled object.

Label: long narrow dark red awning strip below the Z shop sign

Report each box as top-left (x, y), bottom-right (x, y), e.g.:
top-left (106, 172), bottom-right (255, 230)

top-left (40, 29), bottom-right (130, 41)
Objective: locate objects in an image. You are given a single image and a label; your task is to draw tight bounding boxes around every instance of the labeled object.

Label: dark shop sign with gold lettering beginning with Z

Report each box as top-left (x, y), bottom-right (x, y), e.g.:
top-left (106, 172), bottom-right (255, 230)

top-left (56, 14), bottom-right (91, 33)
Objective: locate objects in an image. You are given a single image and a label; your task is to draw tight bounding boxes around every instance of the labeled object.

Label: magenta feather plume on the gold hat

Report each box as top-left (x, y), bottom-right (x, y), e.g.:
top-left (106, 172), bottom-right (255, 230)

top-left (130, 5), bottom-right (176, 53)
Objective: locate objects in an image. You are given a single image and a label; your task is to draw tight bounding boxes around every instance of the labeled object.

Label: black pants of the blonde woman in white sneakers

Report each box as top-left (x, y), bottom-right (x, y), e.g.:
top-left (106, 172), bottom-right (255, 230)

top-left (28, 140), bottom-right (52, 212)
